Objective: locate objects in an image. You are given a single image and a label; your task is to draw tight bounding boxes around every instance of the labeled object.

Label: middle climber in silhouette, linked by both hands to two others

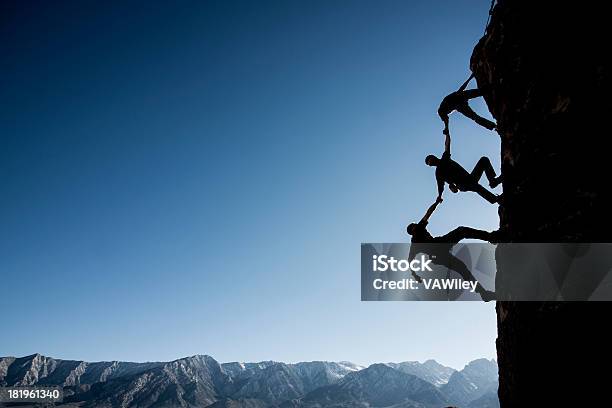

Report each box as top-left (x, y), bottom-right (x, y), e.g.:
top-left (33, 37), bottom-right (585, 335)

top-left (425, 132), bottom-right (502, 204)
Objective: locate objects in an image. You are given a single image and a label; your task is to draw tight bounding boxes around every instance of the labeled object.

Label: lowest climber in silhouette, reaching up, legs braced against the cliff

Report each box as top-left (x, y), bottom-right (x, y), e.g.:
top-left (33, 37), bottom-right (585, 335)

top-left (406, 197), bottom-right (498, 301)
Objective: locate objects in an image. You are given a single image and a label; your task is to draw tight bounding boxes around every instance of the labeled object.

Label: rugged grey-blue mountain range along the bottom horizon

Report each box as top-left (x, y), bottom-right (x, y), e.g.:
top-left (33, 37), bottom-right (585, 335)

top-left (0, 354), bottom-right (499, 408)
